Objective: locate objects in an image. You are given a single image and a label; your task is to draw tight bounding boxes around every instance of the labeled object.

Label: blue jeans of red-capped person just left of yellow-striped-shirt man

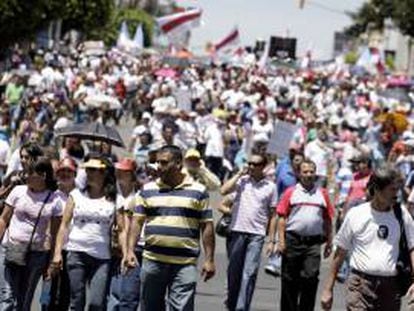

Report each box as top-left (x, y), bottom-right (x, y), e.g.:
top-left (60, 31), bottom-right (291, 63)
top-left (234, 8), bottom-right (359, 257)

top-left (109, 250), bottom-right (142, 311)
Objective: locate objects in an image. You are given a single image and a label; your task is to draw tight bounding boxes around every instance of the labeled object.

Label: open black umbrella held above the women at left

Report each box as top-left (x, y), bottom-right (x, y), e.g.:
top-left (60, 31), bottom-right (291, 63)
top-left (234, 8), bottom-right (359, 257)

top-left (56, 122), bottom-right (125, 147)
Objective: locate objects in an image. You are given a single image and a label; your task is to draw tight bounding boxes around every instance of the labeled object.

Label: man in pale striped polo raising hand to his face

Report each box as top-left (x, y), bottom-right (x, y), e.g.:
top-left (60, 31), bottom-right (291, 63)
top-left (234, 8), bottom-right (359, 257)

top-left (221, 153), bottom-right (277, 311)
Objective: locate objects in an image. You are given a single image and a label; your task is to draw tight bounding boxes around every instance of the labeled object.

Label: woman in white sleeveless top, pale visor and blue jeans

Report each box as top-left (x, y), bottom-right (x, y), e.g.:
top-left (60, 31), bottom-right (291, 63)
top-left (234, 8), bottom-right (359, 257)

top-left (52, 155), bottom-right (116, 311)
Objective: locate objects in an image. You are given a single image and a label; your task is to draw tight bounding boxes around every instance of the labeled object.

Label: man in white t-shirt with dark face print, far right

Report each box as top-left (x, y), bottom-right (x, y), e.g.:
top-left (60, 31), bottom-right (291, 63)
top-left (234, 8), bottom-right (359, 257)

top-left (321, 166), bottom-right (414, 311)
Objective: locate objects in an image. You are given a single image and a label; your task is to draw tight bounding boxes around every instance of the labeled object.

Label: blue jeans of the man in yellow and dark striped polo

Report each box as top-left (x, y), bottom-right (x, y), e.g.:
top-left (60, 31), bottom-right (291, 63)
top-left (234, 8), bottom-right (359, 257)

top-left (141, 259), bottom-right (197, 311)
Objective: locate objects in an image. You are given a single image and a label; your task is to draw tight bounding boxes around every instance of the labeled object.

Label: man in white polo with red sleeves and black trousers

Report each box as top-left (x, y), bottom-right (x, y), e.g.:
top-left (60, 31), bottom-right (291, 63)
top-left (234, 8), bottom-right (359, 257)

top-left (268, 159), bottom-right (334, 311)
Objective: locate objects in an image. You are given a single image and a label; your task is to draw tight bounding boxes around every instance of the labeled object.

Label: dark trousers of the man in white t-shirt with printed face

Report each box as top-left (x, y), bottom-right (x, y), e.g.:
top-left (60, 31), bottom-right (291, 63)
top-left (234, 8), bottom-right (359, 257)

top-left (346, 271), bottom-right (401, 311)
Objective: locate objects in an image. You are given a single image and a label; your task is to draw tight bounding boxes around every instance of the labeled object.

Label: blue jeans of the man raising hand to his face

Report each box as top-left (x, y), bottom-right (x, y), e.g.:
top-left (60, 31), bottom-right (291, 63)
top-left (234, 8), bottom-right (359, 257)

top-left (227, 231), bottom-right (265, 311)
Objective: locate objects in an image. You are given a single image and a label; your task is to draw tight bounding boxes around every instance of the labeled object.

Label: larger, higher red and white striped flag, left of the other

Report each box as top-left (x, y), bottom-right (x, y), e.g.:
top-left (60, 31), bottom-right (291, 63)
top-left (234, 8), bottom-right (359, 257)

top-left (156, 9), bottom-right (202, 35)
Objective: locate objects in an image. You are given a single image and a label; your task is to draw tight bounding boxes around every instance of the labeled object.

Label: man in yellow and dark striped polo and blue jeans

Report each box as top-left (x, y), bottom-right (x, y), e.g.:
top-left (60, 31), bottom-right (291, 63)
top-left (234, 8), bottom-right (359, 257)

top-left (124, 145), bottom-right (215, 311)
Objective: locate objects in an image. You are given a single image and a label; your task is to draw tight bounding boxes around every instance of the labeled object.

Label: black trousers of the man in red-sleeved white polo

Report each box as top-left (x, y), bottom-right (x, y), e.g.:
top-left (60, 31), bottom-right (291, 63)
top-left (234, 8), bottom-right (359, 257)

top-left (280, 232), bottom-right (321, 311)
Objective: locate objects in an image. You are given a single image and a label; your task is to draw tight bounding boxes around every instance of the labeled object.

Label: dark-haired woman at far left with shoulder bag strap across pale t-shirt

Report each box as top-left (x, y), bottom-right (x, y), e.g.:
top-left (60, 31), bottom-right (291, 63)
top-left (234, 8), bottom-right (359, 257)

top-left (0, 157), bottom-right (62, 311)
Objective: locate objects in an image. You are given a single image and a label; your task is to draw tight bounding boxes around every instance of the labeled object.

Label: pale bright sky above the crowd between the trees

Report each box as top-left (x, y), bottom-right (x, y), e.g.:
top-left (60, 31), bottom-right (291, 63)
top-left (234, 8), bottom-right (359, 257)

top-left (176, 0), bottom-right (364, 59)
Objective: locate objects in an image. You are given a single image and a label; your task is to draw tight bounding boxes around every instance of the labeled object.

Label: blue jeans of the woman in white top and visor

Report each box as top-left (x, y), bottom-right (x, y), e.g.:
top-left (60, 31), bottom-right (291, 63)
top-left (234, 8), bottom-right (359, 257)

top-left (66, 252), bottom-right (111, 311)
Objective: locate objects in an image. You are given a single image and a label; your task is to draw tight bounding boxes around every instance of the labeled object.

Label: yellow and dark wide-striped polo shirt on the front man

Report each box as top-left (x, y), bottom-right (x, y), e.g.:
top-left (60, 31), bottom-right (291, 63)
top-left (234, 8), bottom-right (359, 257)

top-left (134, 176), bottom-right (213, 264)
